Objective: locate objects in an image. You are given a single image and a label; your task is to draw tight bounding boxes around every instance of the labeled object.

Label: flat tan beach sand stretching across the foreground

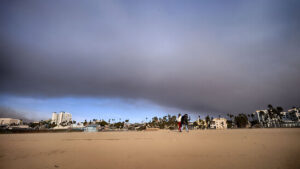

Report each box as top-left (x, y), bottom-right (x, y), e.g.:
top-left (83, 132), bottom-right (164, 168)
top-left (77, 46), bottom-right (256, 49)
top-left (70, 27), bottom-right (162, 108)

top-left (0, 129), bottom-right (300, 169)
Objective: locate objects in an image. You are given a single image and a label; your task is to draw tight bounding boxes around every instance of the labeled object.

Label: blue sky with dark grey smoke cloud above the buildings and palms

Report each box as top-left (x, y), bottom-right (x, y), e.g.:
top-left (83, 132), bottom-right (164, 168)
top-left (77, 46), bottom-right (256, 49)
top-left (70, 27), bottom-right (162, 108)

top-left (0, 0), bottom-right (300, 121)
